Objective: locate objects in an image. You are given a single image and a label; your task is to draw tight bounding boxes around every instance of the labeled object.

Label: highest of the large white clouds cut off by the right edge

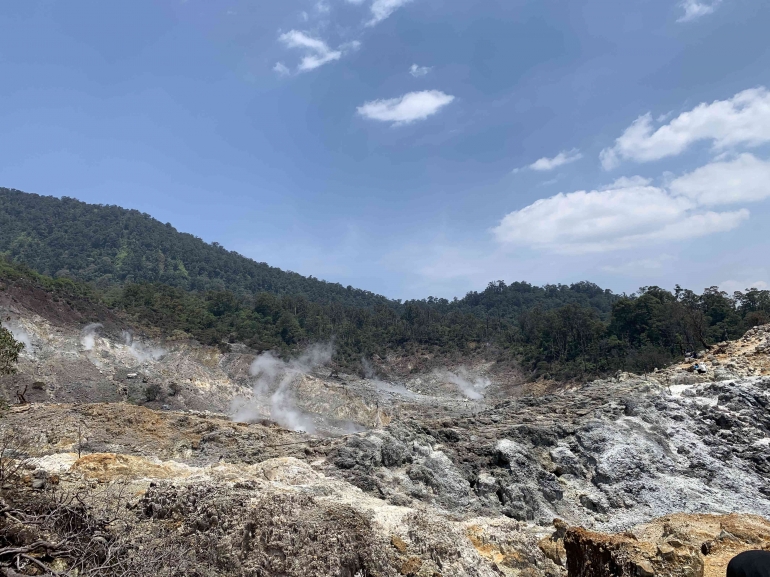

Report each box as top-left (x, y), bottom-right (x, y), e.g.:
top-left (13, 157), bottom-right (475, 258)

top-left (600, 87), bottom-right (770, 170)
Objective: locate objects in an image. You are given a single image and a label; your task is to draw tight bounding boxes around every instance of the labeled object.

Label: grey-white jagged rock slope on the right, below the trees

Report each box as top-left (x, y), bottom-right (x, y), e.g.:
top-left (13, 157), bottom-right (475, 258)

top-left (330, 327), bottom-right (770, 530)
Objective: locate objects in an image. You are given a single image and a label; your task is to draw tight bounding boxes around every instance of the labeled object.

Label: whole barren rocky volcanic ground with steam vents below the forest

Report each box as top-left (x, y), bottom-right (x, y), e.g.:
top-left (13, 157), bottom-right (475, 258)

top-left (0, 282), bottom-right (770, 577)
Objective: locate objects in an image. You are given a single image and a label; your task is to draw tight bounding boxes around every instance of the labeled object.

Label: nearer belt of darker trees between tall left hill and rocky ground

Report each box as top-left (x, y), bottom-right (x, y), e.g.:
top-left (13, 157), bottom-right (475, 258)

top-left (0, 259), bottom-right (770, 379)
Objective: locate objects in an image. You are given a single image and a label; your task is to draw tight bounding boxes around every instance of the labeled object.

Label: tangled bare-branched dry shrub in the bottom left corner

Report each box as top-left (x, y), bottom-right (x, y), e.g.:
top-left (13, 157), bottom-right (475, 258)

top-left (0, 428), bottom-right (204, 577)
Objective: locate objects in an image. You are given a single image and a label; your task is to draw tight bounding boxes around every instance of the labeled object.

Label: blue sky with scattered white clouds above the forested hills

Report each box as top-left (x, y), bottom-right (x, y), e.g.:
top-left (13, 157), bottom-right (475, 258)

top-left (0, 0), bottom-right (770, 299)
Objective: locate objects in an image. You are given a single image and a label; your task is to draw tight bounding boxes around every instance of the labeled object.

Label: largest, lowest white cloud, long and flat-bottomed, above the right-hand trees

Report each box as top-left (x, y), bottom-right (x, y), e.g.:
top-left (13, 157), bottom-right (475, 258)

top-left (493, 176), bottom-right (749, 254)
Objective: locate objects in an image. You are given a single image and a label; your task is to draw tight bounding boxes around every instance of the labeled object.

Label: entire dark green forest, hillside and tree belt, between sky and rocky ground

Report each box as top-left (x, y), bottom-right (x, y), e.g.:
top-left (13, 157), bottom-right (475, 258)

top-left (0, 189), bottom-right (770, 379)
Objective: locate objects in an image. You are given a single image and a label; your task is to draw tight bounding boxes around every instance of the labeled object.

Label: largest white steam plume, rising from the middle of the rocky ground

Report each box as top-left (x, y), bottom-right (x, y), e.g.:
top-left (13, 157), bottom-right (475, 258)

top-left (231, 344), bottom-right (333, 433)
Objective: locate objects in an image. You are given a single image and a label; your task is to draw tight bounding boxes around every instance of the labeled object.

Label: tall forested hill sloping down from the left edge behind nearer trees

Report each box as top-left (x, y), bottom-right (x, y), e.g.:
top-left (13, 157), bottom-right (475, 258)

top-left (0, 188), bottom-right (392, 307)
